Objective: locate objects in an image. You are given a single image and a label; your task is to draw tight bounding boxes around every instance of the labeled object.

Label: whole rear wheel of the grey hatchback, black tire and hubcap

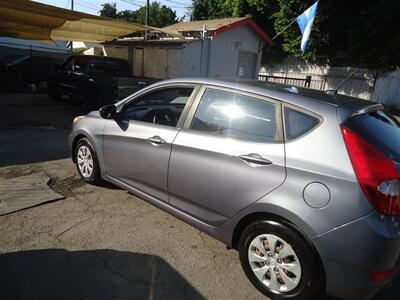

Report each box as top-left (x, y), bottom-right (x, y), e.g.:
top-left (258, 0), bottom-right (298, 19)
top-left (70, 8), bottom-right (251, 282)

top-left (239, 220), bottom-right (325, 299)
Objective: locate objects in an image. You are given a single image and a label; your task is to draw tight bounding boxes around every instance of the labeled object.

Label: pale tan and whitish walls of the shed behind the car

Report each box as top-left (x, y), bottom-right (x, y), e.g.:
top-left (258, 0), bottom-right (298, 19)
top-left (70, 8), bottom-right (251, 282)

top-left (104, 26), bottom-right (262, 79)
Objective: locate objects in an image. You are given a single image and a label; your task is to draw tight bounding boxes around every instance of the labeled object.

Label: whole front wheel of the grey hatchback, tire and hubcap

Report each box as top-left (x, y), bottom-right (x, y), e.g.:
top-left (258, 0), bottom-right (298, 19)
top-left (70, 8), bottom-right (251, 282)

top-left (74, 138), bottom-right (102, 184)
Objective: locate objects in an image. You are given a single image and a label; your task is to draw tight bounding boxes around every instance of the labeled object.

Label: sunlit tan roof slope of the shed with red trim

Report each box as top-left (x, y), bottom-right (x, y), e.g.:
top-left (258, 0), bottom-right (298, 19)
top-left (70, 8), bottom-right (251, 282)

top-left (163, 17), bottom-right (247, 32)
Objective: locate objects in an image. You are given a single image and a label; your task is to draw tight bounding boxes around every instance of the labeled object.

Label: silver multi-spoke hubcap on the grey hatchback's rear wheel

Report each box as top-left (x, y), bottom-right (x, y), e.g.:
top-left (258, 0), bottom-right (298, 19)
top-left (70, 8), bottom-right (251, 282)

top-left (248, 234), bottom-right (301, 293)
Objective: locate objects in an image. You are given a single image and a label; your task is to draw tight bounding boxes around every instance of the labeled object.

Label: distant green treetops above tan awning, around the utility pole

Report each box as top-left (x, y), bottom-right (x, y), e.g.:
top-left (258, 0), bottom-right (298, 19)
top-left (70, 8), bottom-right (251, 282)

top-left (100, 1), bottom-right (177, 27)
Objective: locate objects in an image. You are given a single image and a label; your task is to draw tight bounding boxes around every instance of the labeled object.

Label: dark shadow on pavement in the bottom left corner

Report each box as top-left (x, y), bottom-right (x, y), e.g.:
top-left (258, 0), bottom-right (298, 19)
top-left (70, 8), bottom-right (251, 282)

top-left (0, 249), bottom-right (204, 300)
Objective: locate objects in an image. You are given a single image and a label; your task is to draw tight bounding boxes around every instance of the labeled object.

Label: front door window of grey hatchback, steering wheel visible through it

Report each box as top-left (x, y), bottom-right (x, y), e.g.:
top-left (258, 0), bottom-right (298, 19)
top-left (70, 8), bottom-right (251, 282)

top-left (123, 87), bottom-right (194, 127)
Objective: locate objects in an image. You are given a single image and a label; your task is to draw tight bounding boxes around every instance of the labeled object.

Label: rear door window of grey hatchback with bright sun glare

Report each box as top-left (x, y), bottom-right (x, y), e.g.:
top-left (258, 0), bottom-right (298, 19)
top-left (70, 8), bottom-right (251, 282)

top-left (191, 89), bottom-right (277, 142)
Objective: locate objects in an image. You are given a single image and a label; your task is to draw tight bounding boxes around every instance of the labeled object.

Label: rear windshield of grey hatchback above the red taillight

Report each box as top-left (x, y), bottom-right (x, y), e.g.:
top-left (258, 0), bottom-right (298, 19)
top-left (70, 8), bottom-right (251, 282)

top-left (343, 110), bottom-right (400, 162)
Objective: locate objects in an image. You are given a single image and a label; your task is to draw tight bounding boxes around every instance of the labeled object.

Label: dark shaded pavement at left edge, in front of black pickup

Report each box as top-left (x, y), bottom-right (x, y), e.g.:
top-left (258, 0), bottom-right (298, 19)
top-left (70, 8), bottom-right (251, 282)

top-left (0, 93), bottom-right (90, 167)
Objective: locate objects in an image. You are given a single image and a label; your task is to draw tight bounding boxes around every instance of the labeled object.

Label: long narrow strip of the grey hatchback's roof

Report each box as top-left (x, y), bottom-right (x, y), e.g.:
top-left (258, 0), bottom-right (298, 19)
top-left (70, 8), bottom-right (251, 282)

top-left (156, 78), bottom-right (373, 110)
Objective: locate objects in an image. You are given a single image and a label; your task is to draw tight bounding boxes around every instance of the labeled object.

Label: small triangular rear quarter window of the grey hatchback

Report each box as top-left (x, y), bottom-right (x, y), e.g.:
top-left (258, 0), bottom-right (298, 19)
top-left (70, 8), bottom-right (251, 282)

top-left (285, 107), bottom-right (320, 141)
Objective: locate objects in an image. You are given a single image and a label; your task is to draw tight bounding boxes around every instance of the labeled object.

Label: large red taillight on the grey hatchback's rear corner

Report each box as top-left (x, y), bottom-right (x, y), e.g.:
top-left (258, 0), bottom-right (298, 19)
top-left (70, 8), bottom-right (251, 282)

top-left (342, 127), bottom-right (400, 216)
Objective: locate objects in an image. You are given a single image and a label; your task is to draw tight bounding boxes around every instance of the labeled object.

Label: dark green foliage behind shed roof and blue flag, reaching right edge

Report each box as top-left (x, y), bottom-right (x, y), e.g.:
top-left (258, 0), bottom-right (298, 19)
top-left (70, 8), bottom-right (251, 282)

top-left (192, 0), bottom-right (400, 70)
